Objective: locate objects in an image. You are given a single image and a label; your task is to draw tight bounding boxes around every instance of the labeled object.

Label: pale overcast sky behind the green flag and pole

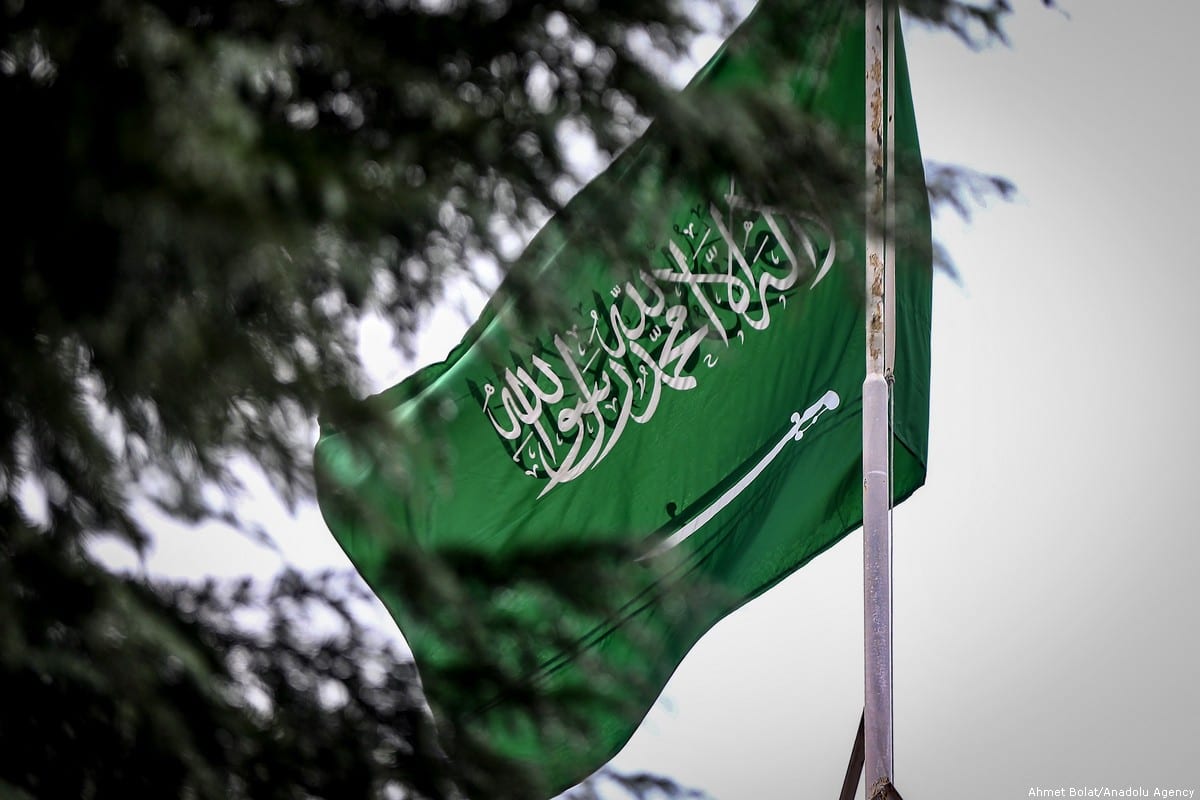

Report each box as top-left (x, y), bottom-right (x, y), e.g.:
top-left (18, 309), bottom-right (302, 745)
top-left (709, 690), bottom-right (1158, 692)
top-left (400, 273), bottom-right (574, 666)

top-left (96, 0), bottom-right (1200, 800)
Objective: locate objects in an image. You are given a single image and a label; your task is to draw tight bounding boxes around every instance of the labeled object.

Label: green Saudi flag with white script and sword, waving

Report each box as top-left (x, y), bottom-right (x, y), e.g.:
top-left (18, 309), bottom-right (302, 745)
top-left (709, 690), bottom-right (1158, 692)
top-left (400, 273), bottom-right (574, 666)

top-left (316, 2), bottom-right (931, 796)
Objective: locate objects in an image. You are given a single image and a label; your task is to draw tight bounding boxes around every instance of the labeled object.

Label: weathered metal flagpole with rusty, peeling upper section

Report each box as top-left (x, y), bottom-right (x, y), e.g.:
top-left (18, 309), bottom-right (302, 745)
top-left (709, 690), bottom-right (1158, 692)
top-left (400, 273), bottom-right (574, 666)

top-left (863, 0), bottom-right (893, 799)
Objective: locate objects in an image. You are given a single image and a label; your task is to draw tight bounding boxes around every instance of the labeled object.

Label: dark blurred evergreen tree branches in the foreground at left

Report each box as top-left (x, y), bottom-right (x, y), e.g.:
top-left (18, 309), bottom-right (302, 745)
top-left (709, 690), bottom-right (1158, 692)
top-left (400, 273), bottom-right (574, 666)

top-left (0, 0), bottom-right (1022, 798)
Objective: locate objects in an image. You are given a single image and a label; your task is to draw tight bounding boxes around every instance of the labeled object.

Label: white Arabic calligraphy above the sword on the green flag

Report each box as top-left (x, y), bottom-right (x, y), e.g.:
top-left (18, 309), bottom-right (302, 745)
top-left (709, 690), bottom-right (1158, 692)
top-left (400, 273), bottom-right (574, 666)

top-left (482, 192), bottom-right (835, 498)
